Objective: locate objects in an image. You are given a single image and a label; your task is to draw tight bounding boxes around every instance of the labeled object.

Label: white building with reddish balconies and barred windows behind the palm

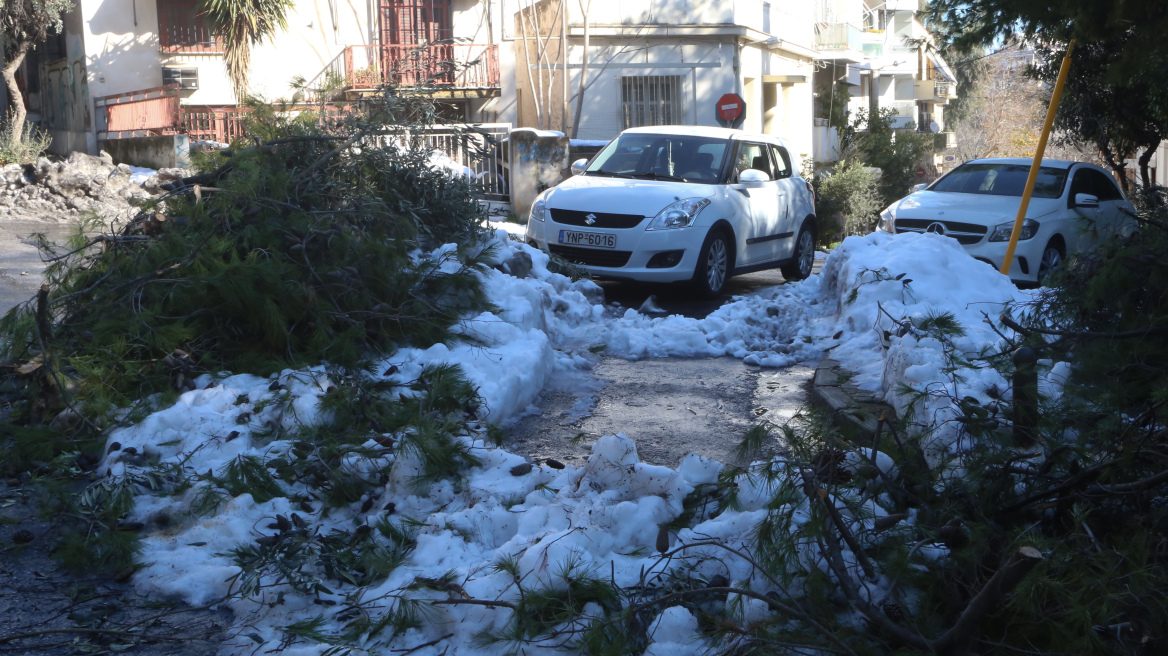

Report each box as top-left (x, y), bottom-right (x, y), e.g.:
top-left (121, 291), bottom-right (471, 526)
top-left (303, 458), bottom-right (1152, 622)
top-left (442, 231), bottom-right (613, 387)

top-left (11, 0), bottom-right (514, 154)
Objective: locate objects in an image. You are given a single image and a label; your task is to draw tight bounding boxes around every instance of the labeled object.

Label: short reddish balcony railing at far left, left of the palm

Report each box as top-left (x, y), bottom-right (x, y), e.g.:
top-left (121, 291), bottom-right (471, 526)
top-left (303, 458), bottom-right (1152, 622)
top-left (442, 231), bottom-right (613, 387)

top-left (93, 84), bottom-right (180, 140)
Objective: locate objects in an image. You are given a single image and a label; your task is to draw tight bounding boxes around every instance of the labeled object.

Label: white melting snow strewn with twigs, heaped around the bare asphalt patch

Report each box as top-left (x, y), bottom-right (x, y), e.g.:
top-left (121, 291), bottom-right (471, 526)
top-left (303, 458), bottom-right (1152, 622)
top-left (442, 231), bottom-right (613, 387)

top-left (104, 231), bottom-right (1041, 656)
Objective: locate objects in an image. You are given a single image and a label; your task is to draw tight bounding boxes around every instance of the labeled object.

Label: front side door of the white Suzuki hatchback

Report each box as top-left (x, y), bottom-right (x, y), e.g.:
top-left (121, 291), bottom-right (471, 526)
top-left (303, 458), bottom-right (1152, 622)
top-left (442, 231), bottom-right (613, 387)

top-left (730, 141), bottom-right (786, 264)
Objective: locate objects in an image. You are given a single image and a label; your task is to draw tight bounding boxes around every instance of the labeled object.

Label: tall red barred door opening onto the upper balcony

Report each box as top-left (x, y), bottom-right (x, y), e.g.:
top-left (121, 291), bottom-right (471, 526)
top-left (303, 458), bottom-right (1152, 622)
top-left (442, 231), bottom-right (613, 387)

top-left (380, 0), bottom-right (454, 86)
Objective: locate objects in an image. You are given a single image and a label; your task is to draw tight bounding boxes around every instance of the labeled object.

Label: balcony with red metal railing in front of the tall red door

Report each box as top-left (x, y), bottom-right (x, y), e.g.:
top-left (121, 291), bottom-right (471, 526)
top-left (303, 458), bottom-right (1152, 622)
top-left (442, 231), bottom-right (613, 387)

top-left (308, 43), bottom-right (500, 98)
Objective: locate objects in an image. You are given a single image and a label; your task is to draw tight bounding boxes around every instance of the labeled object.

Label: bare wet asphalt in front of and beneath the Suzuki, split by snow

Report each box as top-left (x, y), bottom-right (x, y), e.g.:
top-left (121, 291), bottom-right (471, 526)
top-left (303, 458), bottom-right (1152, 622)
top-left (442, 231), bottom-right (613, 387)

top-left (506, 263), bottom-right (821, 467)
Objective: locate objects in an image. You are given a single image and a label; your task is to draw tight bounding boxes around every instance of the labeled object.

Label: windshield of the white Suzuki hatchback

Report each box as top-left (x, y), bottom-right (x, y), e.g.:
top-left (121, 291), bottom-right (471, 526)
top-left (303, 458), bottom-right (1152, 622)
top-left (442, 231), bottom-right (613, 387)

top-left (586, 133), bottom-right (730, 184)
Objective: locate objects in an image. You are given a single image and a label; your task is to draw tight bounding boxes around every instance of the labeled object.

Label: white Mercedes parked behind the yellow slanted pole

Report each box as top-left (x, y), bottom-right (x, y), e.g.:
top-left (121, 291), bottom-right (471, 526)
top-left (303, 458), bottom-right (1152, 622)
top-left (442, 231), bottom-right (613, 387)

top-left (880, 158), bottom-right (1136, 284)
